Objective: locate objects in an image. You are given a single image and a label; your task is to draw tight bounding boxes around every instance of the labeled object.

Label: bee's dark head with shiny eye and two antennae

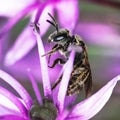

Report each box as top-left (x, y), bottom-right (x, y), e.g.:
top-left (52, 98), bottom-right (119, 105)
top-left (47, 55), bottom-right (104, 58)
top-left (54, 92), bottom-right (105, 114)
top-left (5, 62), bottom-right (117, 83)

top-left (47, 13), bottom-right (70, 44)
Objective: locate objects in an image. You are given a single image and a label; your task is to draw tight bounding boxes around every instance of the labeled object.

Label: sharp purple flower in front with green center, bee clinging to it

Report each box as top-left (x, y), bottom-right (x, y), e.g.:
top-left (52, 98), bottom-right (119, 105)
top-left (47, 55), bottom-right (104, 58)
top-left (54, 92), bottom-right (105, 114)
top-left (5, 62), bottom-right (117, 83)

top-left (0, 24), bottom-right (120, 120)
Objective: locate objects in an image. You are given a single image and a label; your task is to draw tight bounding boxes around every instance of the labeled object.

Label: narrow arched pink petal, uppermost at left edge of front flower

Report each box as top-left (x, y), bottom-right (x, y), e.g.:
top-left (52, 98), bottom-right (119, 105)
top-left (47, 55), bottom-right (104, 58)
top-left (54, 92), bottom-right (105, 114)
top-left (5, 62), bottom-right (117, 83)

top-left (0, 70), bottom-right (32, 109)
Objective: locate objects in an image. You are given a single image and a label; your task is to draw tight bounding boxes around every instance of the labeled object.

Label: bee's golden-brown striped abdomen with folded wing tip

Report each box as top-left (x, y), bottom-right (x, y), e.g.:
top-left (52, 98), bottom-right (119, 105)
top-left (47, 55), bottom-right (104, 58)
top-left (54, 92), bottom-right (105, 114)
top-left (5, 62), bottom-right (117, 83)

top-left (67, 69), bottom-right (92, 97)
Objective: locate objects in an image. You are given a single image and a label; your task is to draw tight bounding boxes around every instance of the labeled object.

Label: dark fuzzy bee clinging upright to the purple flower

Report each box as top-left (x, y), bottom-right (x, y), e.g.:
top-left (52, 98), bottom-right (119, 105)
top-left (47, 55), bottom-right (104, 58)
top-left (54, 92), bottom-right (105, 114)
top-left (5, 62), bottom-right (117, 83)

top-left (43, 13), bottom-right (92, 97)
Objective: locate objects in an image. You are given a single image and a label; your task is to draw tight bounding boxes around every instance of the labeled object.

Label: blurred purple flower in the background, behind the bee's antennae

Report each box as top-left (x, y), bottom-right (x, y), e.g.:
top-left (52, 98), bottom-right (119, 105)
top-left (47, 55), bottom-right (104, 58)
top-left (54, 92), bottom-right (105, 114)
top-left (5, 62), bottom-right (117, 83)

top-left (0, 0), bottom-right (78, 65)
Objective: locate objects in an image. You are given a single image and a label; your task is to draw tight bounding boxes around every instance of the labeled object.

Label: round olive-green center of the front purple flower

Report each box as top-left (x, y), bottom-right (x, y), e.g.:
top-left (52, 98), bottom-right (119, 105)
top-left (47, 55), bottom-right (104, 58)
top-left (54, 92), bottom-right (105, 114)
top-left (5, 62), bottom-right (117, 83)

top-left (30, 99), bottom-right (57, 120)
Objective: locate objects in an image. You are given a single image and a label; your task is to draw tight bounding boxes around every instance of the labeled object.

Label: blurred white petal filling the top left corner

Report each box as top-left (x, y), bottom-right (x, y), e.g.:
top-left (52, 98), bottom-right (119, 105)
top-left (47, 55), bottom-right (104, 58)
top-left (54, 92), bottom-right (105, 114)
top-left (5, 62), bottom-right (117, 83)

top-left (0, 0), bottom-right (34, 17)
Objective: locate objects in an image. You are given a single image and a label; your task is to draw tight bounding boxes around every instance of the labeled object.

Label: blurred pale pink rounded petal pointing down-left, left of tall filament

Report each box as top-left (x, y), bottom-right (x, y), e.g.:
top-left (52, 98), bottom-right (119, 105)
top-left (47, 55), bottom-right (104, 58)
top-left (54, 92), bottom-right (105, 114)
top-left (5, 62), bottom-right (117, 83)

top-left (4, 27), bottom-right (36, 66)
